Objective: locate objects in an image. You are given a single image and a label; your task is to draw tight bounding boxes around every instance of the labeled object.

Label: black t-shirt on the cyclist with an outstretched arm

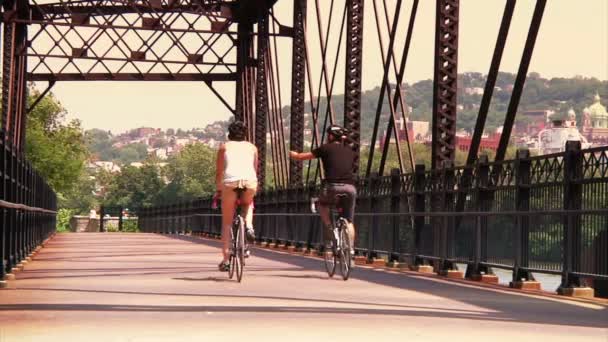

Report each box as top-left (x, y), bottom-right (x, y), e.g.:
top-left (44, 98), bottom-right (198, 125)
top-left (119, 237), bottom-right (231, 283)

top-left (312, 143), bottom-right (355, 184)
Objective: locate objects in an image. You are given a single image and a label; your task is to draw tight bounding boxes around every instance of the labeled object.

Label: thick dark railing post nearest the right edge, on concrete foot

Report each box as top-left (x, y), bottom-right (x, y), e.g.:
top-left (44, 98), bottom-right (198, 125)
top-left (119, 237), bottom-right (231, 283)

top-left (558, 141), bottom-right (593, 296)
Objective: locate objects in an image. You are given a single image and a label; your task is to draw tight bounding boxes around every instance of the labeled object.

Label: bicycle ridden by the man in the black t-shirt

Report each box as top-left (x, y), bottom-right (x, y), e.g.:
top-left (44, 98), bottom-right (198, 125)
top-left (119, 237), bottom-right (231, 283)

top-left (311, 195), bottom-right (352, 281)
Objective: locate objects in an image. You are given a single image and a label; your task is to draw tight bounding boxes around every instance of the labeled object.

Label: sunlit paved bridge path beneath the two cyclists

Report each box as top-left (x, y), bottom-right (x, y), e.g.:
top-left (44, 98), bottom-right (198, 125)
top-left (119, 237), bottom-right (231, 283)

top-left (0, 233), bottom-right (608, 342)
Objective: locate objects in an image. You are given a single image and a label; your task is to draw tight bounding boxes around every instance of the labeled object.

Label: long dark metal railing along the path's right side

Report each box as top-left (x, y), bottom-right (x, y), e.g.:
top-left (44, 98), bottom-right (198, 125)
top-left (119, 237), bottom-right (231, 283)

top-left (139, 142), bottom-right (608, 294)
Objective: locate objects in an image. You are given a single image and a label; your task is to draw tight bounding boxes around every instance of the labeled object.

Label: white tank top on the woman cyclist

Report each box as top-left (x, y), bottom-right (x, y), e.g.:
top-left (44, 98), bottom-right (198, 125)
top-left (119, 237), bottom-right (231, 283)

top-left (224, 141), bottom-right (257, 183)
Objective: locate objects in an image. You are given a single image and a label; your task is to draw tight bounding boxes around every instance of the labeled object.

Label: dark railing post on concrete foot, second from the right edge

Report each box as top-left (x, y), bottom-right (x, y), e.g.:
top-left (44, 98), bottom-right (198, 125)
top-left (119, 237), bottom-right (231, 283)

top-left (509, 149), bottom-right (540, 290)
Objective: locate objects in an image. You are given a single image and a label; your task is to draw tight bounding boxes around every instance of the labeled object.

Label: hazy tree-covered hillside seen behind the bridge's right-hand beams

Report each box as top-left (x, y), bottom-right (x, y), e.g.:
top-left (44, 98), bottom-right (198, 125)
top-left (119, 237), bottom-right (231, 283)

top-left (282, 73), bottom-right (608, 139)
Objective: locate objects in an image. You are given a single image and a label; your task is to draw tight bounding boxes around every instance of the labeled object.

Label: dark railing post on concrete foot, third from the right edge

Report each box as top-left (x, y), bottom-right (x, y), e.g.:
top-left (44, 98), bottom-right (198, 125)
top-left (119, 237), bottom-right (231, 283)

top-left (465, 154), bottom-right (498, 283)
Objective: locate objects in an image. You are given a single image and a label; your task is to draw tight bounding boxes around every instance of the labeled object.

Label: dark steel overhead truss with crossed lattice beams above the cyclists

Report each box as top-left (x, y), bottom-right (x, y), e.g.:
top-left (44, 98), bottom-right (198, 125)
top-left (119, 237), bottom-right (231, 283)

top-left (2, 0), bottom-right (547, 188)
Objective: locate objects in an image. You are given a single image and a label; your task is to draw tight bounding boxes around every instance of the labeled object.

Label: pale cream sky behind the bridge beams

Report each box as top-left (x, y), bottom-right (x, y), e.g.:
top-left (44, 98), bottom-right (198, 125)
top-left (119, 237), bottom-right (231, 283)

top-left (36, 0), bottom-right (608, 133)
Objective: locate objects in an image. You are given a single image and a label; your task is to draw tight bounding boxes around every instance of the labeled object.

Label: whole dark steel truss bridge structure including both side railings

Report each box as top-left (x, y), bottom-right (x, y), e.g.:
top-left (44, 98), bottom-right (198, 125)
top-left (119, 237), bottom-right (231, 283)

top-left (0, 0), bottom-right (608, 295)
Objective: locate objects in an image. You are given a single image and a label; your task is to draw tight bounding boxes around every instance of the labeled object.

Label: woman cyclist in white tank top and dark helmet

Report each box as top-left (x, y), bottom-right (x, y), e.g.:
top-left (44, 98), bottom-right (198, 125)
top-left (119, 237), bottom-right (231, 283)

top-left (215, 121), bottom-right (258, 272)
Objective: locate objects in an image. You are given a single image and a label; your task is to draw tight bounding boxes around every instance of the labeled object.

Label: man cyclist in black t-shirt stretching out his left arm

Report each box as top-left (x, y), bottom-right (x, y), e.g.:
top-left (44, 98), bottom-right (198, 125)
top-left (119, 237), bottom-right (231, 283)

top-left (289, 125), bottom-right (357, 252)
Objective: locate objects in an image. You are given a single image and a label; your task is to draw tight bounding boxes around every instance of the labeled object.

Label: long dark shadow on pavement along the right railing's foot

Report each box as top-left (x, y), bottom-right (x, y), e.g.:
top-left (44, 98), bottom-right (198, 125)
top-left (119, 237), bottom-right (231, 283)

top-left (166, 232), bottom-right (608, 328)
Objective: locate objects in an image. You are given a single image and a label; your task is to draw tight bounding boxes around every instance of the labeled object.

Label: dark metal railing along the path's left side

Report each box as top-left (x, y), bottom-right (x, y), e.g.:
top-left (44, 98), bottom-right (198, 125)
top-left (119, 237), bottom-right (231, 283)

top-left (0, 136), bottom-right (57, 282)
